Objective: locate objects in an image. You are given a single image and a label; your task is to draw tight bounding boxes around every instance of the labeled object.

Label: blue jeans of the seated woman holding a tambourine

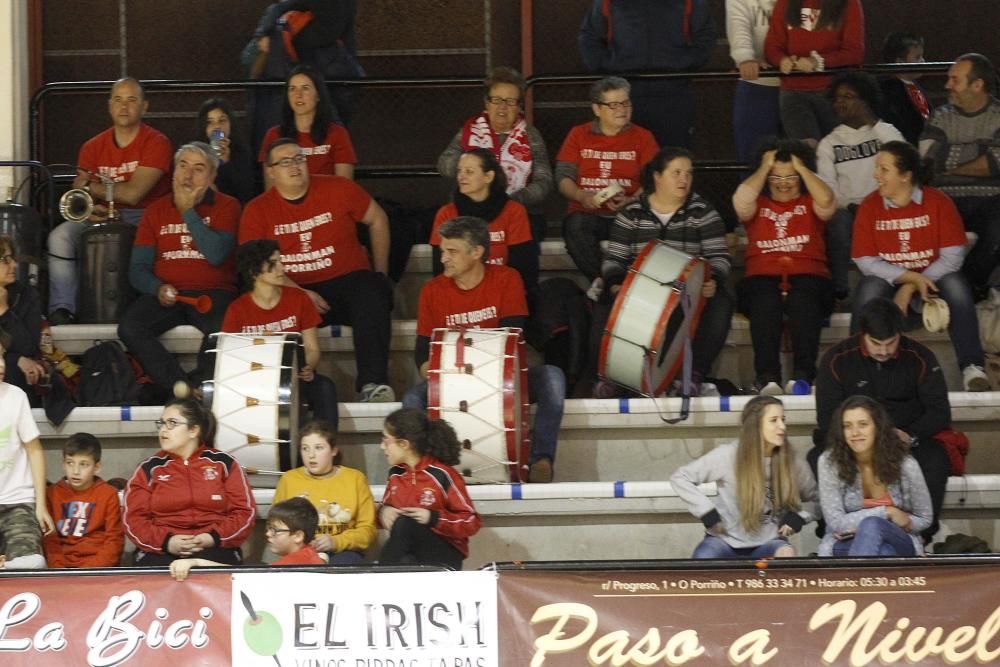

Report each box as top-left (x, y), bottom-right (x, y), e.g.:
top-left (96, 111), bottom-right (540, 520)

top-left (851, 271), bottom-right (983, 369)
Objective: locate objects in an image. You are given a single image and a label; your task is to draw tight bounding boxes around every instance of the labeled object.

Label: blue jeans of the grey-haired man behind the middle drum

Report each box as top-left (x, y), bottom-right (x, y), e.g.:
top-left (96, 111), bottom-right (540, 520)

top-left (403, 364), bottom-right (566, 463)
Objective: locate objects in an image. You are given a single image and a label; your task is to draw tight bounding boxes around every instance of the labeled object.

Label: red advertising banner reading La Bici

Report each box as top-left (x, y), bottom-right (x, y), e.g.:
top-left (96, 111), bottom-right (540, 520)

top-left (0, 573), bottom-right (231, 667)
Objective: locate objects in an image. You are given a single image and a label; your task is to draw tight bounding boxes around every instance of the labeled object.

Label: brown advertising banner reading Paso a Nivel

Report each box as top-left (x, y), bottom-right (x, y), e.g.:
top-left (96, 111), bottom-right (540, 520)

top-left (498, 563), bottom-right (1000, 667)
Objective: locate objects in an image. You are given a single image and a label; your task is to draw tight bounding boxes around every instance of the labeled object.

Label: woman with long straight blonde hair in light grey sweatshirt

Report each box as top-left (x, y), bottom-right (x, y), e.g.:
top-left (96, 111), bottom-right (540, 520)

top-left (670, 396), bottom-right (817, 558)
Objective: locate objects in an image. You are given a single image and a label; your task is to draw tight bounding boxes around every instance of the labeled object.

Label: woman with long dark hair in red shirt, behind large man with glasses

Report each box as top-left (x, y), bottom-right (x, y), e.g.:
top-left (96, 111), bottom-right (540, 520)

top-left (257, 65), bottom-right (358, 190)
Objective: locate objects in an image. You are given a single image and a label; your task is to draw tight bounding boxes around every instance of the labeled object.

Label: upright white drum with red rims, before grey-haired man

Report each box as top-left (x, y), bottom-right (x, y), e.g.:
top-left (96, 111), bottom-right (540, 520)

top-left (427, 328), bottom-right (529, 484)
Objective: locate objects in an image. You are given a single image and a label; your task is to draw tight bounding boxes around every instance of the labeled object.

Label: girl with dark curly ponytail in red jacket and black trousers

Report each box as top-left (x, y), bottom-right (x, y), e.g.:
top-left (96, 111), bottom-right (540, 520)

top-left (378, 408), bottom-right (482, 570)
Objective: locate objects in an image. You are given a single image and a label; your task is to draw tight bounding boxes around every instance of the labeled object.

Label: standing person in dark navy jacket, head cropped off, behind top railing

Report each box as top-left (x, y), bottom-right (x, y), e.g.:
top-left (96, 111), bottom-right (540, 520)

top-left (579, 0), bottom-right (715, 148)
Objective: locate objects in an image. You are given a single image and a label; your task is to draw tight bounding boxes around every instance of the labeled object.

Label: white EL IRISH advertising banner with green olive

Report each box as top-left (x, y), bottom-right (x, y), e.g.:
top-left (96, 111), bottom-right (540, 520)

top-left (232, 572), bottom-right (499, 667)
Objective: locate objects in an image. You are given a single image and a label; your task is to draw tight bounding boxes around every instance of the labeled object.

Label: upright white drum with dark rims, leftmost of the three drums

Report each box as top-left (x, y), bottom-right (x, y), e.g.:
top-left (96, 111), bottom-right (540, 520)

top-left (202, 333), bottom-right (299, 474)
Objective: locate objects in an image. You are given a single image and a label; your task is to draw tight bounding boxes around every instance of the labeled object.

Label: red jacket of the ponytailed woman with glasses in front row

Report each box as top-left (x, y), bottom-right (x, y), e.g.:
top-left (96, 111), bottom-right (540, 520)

top-left (124, 447), bottom-right (257, 553)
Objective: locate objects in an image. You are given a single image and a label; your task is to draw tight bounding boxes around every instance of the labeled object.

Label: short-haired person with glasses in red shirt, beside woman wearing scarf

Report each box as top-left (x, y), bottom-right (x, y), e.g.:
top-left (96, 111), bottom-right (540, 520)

top-left (556, 76), bottom-right (658, 292)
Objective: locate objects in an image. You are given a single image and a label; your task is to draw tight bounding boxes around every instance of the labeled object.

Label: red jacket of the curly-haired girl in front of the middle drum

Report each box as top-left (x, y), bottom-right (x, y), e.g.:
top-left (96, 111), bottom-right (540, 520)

top-left (382, 456), bottom-right (482, 556)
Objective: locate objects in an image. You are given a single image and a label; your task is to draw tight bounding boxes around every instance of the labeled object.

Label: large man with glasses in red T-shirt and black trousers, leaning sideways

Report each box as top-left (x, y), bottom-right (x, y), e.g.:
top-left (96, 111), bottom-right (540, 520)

top-left (239, 139), bottom-right (396, 403)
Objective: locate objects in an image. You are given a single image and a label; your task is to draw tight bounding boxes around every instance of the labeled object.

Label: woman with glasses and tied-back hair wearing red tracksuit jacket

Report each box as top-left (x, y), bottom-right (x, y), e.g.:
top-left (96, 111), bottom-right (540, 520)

top-left (122, 398), bottom-right (257, 565)
